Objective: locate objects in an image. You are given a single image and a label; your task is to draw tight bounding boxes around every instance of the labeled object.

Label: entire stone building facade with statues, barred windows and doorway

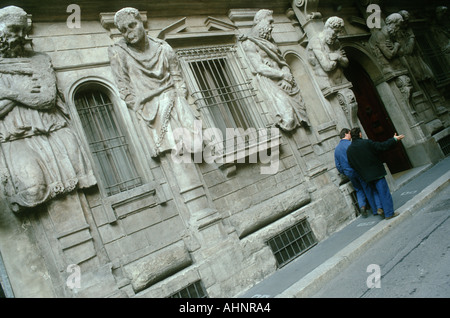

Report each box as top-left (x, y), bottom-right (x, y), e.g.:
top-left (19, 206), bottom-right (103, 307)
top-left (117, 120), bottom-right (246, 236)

top-left (0, 0), bottom-right (450, 297)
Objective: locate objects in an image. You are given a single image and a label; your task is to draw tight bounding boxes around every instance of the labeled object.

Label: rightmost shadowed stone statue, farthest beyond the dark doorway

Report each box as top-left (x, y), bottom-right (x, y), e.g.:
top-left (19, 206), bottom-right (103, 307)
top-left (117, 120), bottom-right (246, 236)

top-left (397, 10), bottom-right (433, 81)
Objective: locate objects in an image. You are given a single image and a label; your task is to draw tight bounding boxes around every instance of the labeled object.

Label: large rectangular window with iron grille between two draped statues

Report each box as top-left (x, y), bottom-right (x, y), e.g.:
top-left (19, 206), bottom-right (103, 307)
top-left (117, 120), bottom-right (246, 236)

top-left (177, 45), bottom-right (267, 150)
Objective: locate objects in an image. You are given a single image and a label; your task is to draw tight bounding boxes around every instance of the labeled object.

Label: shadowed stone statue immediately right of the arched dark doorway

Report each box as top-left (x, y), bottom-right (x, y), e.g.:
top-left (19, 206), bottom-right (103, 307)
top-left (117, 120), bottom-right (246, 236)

top-left (369, 13), bottom-right (406, 77)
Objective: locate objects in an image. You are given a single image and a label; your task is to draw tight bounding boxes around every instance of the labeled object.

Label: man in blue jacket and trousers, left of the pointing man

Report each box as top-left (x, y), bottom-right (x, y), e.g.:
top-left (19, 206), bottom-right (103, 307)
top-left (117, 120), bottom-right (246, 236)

top-left (334, 128), bottom-right (383, 217)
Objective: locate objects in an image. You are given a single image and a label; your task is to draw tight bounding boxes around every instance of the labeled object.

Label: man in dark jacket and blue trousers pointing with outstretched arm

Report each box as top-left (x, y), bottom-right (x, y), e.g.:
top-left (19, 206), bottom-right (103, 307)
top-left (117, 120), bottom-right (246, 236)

top-left (347, 127), bottom-right (405, 219)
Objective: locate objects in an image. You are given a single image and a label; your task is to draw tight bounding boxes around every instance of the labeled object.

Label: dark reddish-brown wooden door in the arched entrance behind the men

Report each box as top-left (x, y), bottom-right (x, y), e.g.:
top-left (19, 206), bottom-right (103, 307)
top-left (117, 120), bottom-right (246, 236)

top-left (345, 60), bottom-right (412, 173)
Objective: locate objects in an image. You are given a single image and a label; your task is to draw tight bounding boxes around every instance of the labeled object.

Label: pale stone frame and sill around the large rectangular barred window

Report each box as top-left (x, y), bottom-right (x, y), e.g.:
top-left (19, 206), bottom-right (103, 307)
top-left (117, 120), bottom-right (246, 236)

top-left (175, 43), bottom-right (280, 166)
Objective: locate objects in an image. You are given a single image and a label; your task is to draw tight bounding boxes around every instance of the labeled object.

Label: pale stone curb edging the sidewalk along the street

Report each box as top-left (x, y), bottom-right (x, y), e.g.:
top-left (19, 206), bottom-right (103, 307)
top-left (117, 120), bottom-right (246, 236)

top-left (275, 171), bottom-right (450, 298)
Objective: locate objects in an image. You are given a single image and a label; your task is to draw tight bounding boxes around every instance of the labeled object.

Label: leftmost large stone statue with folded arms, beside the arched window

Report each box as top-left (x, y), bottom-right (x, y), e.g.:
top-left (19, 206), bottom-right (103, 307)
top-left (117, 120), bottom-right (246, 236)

top-left (0, 6), bottom-right (96, 212)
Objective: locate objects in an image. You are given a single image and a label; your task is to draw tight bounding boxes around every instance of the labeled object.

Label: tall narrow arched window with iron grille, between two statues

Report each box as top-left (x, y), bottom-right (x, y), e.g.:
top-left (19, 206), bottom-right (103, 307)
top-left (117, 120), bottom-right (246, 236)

top-left (74, 89), bottom-right (142, 196)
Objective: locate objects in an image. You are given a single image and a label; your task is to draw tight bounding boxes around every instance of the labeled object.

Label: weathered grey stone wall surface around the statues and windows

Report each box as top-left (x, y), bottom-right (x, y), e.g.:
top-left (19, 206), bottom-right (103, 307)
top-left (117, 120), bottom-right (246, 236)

top-left (0, 1), bottom-right (446, 297)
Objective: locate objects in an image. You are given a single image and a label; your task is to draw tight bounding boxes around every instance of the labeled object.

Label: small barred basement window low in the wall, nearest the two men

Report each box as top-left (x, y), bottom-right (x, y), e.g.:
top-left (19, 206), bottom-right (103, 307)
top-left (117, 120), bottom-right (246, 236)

top-left (267, 219), bottom-right (317, 267)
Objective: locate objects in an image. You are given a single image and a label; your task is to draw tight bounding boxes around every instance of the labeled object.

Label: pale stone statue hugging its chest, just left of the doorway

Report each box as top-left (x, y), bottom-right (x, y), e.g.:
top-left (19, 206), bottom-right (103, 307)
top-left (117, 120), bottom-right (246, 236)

top-left (307, 17), bottom-right (348, 90)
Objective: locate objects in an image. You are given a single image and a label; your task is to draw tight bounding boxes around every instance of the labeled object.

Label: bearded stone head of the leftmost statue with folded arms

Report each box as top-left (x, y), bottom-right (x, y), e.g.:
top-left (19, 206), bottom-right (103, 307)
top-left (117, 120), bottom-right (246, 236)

top-left (0, 6), bottom-right (28, 58)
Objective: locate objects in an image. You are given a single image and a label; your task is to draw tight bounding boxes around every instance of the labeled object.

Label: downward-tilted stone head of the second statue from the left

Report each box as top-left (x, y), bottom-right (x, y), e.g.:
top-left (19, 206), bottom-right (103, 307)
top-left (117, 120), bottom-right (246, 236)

top-left (114, 7), bottom-right (146, 46)
